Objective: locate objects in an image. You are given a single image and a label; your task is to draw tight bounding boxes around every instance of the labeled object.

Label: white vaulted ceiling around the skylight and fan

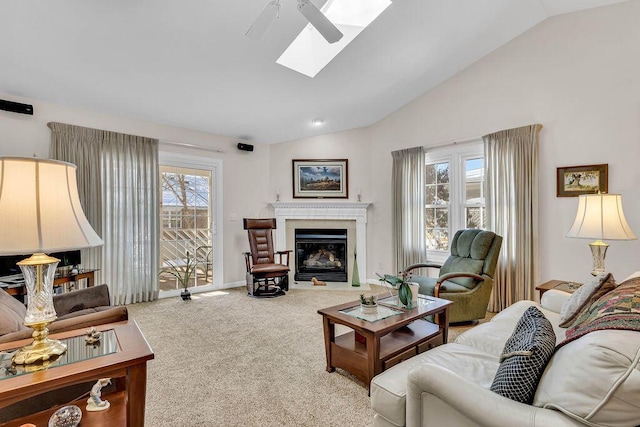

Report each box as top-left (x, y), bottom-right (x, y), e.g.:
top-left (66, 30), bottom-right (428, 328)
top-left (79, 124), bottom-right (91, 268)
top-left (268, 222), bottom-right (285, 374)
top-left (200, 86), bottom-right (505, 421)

top-left (0, 0), bottom-right (632, 143)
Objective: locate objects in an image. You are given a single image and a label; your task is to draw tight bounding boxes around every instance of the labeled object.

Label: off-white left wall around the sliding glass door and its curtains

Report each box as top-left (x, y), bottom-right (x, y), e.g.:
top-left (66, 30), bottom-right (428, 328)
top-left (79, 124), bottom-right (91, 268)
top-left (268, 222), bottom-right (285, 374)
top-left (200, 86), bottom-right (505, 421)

top-left (0, 93), bottom-right (269, 285)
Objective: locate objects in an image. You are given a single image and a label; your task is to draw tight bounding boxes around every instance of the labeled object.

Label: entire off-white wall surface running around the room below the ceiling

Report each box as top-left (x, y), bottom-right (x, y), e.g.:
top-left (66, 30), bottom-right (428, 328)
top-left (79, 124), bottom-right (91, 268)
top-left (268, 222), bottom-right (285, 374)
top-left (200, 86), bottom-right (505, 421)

top-left (5, 0), bottom-right (640, 290)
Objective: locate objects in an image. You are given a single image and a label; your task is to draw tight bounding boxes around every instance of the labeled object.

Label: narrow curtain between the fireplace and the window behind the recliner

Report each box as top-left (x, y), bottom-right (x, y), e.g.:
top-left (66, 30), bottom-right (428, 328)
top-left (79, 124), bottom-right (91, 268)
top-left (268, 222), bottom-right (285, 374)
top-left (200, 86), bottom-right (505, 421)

top-left (391, 147), bottom-right (426, 271)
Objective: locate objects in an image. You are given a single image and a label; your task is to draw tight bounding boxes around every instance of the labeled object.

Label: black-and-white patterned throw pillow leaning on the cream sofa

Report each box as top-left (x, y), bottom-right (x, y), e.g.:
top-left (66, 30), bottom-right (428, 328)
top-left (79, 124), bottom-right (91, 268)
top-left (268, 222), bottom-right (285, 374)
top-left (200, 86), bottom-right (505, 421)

top-left (491, 307), bottom-right (556, 403)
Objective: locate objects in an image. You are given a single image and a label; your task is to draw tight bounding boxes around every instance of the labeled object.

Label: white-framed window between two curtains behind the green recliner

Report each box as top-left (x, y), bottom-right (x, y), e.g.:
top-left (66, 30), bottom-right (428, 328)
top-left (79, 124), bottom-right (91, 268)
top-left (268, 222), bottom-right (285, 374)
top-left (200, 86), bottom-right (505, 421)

top-left (425, 141), bottom-right (486, 259)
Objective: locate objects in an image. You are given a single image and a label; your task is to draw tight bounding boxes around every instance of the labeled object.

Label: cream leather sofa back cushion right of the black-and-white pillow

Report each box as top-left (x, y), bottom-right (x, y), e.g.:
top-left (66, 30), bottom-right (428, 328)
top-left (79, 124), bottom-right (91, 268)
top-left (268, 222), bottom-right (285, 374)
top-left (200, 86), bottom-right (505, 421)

top-left (533, 330), bottom-right (640, 427)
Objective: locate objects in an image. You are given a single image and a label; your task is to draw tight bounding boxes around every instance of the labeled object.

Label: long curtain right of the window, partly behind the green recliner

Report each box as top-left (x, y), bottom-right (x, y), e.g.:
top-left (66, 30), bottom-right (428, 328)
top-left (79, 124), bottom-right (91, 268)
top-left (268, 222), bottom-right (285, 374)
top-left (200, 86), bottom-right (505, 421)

top-left (482, 124), bottom-right (542, 312)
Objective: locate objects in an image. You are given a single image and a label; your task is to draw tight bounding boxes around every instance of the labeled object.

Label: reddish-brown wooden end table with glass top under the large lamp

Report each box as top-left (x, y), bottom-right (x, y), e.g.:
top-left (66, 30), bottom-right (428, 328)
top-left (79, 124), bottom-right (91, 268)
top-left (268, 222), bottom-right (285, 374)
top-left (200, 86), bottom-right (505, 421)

top-left (0, 320), bottom-right (154, 427)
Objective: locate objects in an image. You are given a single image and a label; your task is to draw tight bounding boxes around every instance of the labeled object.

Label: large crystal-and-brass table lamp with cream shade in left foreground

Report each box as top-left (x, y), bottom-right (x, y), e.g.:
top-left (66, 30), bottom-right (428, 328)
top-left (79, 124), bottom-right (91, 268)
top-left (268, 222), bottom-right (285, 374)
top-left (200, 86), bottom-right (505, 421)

top-left (0, 157), bottom-right (103, 364)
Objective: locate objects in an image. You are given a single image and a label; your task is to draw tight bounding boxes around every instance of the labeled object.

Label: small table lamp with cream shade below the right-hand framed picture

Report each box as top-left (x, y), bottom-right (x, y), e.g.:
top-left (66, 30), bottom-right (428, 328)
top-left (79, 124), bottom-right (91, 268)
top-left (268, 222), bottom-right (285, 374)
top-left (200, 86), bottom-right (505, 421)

top-left (567, 194), bottom-right (636, 276)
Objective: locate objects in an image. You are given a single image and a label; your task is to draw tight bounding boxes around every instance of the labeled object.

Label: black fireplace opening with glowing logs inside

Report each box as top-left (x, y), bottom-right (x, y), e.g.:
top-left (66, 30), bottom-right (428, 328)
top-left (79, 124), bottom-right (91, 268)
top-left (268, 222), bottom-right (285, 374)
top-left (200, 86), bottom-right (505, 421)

top-left (294, 228), bottom-right (348, 282)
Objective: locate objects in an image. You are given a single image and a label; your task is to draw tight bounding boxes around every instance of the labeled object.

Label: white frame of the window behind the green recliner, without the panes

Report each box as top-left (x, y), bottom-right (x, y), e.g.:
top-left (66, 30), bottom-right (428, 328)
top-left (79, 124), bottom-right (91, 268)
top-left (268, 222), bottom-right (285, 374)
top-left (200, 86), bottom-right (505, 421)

top-left (424, 138), bottom-right (486, 263)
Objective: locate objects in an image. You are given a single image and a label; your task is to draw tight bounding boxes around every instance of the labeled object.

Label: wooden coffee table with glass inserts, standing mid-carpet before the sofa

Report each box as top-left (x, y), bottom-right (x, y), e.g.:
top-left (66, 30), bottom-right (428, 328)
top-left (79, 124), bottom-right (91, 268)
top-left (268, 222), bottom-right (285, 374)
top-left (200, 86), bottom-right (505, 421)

top-left (318, 296), bottom-right (453, 387)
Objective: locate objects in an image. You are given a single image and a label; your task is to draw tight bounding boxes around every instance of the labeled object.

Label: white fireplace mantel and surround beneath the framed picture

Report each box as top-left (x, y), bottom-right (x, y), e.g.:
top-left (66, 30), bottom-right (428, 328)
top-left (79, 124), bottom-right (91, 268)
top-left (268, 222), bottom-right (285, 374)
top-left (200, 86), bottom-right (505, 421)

top-left (271, 200), bottom-right (371, 282)
